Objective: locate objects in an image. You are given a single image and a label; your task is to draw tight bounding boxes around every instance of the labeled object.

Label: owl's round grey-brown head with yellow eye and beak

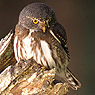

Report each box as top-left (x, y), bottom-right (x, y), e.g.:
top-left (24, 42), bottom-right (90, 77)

top-left (18, 3), bottom-right (56, 32)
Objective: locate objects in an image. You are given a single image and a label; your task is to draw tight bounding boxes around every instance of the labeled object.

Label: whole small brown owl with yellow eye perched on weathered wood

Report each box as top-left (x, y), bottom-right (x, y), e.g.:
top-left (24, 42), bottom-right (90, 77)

top-left (14, 3), bottom-right (81, 90)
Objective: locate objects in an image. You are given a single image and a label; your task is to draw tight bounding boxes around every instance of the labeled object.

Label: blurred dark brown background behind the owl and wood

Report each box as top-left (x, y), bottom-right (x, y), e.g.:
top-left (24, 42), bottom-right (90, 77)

top-left (0, 0), bottom-right (95, 95)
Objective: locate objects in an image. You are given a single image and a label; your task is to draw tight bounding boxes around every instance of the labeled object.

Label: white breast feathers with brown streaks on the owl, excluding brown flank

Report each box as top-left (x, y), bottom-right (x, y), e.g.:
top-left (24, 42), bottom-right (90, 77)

top-left (14, 30), bottom-right (55, 68)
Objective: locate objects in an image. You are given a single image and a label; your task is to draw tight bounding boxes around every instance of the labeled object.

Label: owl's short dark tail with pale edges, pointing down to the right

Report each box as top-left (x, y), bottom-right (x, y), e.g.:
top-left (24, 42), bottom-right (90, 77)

top-left (65, 68), bottom-right (81, 90)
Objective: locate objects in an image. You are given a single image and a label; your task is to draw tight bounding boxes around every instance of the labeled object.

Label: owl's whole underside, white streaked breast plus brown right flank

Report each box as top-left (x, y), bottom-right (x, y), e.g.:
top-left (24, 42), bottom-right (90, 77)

top-left (14, 31), bottom-right (68, 68)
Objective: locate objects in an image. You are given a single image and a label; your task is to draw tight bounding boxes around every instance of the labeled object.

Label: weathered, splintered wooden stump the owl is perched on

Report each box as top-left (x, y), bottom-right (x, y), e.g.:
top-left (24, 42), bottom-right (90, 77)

top-left (0, 32), bottom-right (69, 95)
